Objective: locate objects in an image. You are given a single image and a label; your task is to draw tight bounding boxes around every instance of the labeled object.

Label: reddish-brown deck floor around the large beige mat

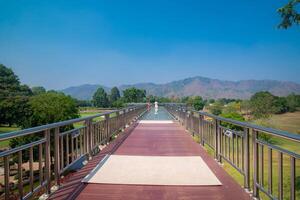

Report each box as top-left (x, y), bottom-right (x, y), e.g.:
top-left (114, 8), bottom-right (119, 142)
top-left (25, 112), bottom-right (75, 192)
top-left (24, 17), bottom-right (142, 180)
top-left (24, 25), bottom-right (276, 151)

top-left (50, 123), bottom-right (250, 200)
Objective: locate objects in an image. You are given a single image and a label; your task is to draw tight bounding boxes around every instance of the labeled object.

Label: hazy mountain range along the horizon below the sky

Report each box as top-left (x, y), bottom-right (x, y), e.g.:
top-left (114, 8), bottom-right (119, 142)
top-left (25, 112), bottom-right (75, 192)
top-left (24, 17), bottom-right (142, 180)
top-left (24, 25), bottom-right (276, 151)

top-left (62, 76), bottom-right (300, 100)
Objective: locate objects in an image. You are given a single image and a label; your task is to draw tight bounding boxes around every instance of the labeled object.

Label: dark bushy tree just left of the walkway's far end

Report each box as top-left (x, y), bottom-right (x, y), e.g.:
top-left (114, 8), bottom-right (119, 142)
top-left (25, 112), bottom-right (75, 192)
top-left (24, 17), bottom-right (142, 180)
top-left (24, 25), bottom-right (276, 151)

top-left (123, 87), bottom-right (146, 103)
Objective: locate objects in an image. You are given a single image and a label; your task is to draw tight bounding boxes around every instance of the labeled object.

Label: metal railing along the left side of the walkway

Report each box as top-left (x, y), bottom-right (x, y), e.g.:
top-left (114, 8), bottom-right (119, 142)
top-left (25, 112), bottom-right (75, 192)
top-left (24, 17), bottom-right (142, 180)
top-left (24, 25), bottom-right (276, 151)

top-left (0, 105), bottom-right (146, 200)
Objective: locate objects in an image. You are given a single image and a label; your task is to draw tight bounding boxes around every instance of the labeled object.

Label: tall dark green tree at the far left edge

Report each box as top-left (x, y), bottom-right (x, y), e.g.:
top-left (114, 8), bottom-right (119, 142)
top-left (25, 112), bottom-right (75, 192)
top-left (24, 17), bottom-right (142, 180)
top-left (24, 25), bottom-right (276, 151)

top-left (0, 64), bottom-right (32, 125)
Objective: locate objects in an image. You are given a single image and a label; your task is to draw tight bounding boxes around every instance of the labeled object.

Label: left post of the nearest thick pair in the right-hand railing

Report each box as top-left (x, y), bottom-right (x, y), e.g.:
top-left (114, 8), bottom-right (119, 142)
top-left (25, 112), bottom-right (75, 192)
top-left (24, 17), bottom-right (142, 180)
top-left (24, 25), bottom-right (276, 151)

top-left (243, 127), bottom-right (250, 190)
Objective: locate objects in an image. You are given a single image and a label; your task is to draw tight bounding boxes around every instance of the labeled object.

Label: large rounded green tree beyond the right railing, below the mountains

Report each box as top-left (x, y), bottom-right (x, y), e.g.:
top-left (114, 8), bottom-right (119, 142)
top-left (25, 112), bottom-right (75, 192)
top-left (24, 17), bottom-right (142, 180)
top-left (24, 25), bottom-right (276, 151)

top-left (250, 91), bottom-right (275, 118)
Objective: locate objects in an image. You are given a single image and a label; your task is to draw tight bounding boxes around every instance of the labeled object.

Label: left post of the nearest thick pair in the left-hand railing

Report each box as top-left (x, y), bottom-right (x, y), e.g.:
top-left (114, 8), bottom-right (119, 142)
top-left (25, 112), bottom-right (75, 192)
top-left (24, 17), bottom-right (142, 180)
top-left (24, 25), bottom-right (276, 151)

top-left (45, 129), bottom-right (51, 194)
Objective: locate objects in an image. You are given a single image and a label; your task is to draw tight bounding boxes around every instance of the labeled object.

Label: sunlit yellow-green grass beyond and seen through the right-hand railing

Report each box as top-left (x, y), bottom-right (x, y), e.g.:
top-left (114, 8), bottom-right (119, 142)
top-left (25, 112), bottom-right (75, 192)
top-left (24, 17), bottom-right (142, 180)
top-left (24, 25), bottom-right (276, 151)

top-left (194, 112), bottom-right (300, 200)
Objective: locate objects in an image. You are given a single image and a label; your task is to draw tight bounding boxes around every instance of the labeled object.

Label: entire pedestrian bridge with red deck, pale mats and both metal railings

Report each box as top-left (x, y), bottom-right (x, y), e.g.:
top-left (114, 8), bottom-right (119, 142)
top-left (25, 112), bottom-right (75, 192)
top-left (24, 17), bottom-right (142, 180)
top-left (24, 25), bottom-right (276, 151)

top-left (0, 104), bottom-right (300, 200)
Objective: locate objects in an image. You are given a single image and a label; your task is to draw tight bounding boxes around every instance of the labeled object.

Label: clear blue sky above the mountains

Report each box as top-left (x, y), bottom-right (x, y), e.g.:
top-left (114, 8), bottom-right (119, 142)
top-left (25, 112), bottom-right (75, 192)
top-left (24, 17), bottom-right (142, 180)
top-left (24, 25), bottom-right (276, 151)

top-left (0, 0), bottom-right (300, 89)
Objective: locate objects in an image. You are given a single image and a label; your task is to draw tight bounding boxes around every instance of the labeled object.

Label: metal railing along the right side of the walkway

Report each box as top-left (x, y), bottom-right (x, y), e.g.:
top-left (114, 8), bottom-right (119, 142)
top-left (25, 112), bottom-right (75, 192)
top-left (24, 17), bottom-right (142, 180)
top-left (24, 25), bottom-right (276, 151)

top-left (164, 103), bottom-right (300, 200)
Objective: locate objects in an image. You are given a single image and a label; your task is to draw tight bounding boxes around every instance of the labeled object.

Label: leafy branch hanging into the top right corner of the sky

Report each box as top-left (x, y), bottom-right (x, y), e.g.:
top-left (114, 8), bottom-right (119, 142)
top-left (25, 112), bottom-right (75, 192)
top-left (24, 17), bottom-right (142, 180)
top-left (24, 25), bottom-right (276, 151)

top-left (277, 0), bottom-right (300, 29)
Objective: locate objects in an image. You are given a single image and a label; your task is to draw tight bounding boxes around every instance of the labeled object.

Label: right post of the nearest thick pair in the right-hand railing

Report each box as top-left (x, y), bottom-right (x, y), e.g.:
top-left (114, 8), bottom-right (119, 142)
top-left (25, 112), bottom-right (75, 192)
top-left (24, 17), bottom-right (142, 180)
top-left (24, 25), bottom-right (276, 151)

top-left (252, 130), bottom-right (259, 198)
